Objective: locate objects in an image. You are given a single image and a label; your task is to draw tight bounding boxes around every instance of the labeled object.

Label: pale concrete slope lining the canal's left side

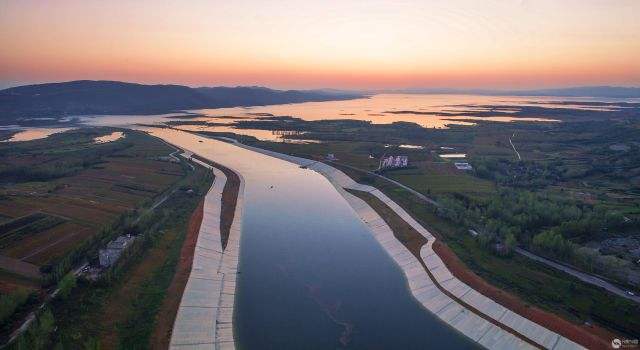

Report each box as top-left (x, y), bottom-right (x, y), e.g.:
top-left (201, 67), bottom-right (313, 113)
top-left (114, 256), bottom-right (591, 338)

top-left (170, 160), bottom-right (244, 349)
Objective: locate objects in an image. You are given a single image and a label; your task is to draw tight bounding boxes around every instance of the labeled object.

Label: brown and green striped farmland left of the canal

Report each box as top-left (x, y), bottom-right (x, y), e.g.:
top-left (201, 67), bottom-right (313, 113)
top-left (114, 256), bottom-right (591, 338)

top-left (0, 128), bottom-right (183, 284)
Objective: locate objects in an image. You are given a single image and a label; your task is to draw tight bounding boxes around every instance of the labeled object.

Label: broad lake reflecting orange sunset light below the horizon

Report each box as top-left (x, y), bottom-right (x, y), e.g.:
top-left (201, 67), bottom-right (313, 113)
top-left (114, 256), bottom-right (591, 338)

top-left (81, 94), bottom-right (639, 142)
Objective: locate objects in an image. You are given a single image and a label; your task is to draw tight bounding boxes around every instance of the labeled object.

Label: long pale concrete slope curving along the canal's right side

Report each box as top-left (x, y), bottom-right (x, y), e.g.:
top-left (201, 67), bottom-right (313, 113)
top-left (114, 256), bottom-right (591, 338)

top-left (232, 144), bottom-right (583, 350)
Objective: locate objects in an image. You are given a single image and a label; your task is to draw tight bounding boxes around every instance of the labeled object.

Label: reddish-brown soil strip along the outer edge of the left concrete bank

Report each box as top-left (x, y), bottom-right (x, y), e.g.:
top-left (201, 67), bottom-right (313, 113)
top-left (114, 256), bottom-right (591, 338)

top-left (149, 199), bottom-right (204, 349)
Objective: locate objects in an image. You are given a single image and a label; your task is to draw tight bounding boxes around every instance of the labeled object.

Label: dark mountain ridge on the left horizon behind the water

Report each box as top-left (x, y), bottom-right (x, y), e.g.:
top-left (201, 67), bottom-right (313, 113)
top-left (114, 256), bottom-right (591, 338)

top-left (0, 80), bottom-right (362, 123)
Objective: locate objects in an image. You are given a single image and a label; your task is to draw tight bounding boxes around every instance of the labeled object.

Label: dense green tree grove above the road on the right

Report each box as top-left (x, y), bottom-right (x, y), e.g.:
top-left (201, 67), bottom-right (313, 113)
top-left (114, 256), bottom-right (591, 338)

top-left (436, 183), bottom-right (639, 284)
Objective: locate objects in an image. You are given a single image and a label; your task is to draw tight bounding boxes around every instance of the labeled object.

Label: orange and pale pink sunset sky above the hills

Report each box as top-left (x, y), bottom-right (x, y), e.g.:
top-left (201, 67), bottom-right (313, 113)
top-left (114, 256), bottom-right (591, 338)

top-left (0, 0), bottom-right (640, 89)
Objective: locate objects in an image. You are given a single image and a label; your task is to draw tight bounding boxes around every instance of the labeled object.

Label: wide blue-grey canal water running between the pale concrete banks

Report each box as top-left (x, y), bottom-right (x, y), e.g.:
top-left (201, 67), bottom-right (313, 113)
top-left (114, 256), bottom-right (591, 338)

top-left (148, 129), bottom-right (475, 349)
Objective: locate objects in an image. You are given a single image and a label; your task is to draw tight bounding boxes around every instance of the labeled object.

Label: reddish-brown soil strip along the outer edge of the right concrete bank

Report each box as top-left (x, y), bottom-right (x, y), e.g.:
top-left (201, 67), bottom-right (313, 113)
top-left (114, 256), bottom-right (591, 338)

top-left (432, 240), bottom-right (615, 349)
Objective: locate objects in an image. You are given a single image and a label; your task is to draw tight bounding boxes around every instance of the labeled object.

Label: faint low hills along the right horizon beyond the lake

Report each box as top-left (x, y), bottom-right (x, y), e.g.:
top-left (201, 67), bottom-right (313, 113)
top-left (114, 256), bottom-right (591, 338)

top-left (386, 86), bottom-right (640, 98)
